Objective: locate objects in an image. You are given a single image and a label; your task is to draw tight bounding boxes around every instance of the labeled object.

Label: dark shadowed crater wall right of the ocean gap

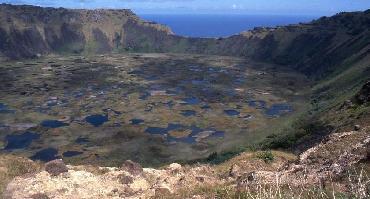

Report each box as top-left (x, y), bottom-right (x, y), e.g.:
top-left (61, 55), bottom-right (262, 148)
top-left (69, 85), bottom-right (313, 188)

top-left (205, 11), bottom-right (370, 77)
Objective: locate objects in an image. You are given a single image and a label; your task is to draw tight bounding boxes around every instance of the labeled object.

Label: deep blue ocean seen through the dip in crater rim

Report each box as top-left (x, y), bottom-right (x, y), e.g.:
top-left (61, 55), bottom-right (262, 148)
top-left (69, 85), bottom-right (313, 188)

top-left (139, 14), bottom-right (319, 37)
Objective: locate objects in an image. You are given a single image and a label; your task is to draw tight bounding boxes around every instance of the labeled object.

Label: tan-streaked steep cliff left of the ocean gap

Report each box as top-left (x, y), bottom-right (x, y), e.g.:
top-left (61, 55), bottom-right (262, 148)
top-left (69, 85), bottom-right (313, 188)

top-left (0, 4), bottom-right (172, 59)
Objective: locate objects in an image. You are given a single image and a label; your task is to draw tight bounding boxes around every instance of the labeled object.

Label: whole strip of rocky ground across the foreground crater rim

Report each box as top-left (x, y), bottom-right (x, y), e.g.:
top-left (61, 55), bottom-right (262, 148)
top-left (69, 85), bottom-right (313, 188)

top-left (4, 127), bottom-right (370, 199)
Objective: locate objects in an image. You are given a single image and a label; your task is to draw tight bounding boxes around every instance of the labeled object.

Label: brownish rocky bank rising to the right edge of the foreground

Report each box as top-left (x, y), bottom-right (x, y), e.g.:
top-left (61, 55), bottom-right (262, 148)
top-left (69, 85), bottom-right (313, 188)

top-left (238, 127), bottom-right (370, 188)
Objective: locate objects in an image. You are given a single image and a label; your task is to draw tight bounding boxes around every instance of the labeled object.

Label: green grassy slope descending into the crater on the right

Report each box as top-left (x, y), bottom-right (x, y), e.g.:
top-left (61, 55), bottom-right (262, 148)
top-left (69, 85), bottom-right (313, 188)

top-left (194, 51), bottom-right (370, 164)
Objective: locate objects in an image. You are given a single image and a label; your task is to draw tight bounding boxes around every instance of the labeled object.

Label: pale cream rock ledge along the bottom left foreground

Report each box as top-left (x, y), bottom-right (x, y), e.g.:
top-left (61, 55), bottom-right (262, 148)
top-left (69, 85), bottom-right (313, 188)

top-left (5, 161), bottom-right (222, 198)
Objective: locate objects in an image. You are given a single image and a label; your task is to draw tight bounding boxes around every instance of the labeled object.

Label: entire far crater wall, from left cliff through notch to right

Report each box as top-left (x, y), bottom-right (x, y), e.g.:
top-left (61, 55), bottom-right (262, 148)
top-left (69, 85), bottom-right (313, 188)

top-left (0, 4), bottom-right (370, 78)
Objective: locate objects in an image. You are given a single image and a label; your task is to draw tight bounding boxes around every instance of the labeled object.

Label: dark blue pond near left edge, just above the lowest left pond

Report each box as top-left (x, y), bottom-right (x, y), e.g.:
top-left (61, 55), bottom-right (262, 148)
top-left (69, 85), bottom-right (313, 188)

top-left (5, 132), bottom-right (40, 150)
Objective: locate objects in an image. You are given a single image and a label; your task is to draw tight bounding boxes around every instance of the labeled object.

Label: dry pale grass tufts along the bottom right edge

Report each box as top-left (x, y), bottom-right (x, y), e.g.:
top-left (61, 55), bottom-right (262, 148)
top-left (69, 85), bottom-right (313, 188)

top-left (157, 166), bottom-right (370, 199)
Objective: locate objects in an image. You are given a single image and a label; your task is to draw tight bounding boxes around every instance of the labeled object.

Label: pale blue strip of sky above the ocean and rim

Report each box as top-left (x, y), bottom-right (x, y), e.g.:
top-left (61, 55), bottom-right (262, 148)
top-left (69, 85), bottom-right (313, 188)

top-left (0, 0), bottom-right (370, 16)
